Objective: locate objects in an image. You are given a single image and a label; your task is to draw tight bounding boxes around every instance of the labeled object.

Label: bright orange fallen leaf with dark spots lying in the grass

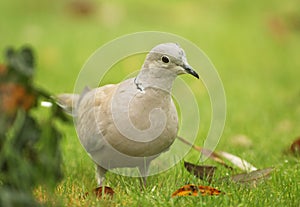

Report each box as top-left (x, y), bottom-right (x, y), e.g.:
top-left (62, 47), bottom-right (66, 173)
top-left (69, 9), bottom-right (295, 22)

top-left (172, 184), bottom-right (221, 197)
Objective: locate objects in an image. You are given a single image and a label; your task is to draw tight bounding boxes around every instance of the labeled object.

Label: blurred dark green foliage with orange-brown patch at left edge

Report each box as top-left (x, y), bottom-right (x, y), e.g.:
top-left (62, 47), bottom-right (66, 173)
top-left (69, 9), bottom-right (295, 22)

top-left (0, 47), bottom-right (67, 206)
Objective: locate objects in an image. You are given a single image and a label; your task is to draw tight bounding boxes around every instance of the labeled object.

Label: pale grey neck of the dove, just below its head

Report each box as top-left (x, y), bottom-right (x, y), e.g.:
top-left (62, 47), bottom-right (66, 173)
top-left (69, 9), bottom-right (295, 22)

top-left (134, 68), bottom-right (176, 93)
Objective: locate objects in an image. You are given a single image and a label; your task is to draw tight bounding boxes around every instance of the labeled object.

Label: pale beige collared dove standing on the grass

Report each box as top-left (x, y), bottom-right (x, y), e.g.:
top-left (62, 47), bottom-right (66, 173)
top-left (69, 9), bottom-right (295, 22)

top-left (57, 43), bottom-right (199, 186)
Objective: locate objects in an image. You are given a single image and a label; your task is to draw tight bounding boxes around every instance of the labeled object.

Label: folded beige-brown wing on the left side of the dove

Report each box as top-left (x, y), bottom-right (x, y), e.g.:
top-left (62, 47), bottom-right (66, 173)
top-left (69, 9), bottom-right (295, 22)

top-left (76, 84), bottom-right (118, 153)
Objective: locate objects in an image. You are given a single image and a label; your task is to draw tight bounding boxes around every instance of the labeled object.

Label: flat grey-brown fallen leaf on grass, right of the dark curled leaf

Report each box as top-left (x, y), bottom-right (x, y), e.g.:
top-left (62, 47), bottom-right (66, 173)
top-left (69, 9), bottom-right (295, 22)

top-left (219, 167), bottom-right (274, 186)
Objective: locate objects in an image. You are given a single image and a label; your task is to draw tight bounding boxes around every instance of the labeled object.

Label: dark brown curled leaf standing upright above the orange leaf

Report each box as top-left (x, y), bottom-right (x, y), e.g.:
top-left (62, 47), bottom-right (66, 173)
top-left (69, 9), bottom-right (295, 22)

top-left (184, 161), bottom-right (216, 182)
